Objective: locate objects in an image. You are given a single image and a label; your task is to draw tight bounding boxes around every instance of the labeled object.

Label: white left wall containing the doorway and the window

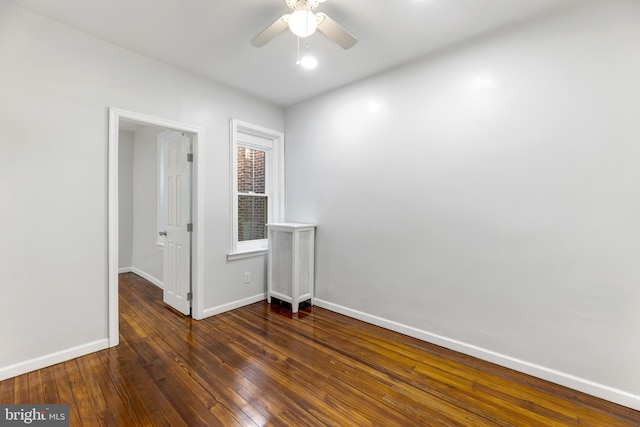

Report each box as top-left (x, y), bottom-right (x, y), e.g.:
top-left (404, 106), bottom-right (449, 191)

top-left (0, 0), bottom-right (284, 379)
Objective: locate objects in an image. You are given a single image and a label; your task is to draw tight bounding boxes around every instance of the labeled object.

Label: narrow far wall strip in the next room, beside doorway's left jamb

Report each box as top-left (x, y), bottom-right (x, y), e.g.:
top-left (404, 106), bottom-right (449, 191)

top-left (118, 131), bottom-right (134, 269)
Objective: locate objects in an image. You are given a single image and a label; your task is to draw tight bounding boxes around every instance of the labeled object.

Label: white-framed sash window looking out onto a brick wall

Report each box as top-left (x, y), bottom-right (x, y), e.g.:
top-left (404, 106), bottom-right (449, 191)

top-left (228, 119), bottom-right (284, 259)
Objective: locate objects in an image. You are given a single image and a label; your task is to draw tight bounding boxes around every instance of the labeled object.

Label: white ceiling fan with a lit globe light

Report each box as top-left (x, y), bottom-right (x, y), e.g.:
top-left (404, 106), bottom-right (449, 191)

top-left (251, 0), bottom-right (358, 49)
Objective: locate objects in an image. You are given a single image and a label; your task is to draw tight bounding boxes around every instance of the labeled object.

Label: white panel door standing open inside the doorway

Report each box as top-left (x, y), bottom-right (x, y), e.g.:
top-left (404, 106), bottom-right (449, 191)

top-left (162, 133), bottom-right (191, 315)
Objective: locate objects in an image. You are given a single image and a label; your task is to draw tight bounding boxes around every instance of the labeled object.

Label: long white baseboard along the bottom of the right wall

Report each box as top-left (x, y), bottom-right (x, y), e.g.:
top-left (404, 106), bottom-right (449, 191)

top-left (314, 298), bottom-right (640, 410)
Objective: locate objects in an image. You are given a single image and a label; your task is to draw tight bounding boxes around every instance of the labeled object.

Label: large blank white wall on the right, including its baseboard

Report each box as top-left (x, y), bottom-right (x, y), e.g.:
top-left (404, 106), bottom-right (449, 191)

top-left (285, 0), bottom-right (640, 408)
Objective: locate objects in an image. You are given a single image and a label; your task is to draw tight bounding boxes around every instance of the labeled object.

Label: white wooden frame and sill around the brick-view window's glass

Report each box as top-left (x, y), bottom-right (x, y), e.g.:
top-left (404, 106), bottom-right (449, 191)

top-left (227, 118), bottom-right (284, 261)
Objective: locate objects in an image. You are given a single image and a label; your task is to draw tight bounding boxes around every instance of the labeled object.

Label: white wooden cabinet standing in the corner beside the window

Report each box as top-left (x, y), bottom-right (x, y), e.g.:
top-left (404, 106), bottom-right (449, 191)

top-left (267, 223), bottom-right (316, 313)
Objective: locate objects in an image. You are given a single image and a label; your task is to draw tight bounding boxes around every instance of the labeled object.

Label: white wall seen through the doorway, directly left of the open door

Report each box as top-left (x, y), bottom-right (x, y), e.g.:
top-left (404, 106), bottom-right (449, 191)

top-left (131, 126), bottom-right (164, 284)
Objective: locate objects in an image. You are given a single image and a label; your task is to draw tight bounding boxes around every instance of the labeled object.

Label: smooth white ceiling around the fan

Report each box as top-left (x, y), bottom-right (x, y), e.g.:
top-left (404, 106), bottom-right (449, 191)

top-left (6, 0), bottom-right (585, 106)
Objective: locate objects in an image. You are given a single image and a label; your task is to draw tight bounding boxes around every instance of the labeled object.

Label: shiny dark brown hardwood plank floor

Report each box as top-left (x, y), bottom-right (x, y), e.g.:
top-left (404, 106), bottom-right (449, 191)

top-left (0, 273), bottom-right (640, 427)
